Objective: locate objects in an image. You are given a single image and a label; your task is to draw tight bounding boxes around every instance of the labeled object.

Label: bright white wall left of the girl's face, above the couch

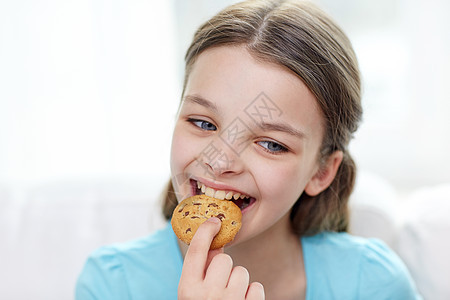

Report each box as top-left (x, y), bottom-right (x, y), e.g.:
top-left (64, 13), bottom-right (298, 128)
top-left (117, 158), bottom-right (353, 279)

top-left (0, 0), bottom-right (180, 192)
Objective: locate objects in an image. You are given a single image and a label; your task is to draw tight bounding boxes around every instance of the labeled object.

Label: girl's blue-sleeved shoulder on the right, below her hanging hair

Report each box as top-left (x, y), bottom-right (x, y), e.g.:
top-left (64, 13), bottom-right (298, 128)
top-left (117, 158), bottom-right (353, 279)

top-left (302, 232), bottom-right (420, 299)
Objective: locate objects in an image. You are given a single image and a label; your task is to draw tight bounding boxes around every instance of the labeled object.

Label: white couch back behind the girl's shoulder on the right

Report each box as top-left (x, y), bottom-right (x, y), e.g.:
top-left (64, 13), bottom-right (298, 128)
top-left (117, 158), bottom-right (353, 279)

top-left (351, 173), bottom-right (450, 300)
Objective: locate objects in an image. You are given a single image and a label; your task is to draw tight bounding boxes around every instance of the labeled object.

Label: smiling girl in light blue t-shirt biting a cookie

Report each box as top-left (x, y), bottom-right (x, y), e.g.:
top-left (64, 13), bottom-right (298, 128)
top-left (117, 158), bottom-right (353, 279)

top-left (76, 0), bottom-right (420, 299)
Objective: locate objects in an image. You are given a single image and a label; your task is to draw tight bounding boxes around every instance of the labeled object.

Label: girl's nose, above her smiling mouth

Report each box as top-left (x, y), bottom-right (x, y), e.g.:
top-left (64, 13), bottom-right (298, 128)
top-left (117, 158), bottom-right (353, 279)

top-left (198, 139), bottom-right (244, 178)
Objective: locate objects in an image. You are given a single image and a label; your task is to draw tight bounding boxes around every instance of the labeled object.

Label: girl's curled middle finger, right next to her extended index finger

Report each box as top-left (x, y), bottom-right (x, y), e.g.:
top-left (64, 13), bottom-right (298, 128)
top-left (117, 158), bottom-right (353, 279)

top-left (205, 253), bottom-right (233, 291)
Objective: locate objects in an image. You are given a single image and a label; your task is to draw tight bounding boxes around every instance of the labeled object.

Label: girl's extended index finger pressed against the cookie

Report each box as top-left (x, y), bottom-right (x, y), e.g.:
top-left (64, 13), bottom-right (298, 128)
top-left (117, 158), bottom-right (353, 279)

top-left (181, 218), bottom-right (221, 280)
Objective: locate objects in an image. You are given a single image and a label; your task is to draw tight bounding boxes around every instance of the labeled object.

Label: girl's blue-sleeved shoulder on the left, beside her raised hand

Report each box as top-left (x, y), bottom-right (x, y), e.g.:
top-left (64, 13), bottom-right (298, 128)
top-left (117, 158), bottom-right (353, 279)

top-left (76, 224), bottom-right (182, 299)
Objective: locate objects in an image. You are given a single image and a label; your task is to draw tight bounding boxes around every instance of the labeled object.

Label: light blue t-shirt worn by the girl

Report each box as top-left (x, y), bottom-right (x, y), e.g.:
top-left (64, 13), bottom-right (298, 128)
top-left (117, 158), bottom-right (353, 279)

top-left (76, 224), bottom-right (422, 300)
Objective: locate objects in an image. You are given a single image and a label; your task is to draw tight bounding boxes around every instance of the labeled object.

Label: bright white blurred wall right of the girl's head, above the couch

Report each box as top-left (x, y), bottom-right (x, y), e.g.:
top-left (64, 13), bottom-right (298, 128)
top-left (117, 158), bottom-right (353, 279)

top-left (317, 0), bottom-right (450, 191)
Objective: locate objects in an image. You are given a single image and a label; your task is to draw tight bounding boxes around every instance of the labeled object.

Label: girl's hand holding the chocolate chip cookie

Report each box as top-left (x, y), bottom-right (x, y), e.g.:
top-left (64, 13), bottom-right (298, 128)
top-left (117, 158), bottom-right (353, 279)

top-left (178, 218), bottom-right (264, 300)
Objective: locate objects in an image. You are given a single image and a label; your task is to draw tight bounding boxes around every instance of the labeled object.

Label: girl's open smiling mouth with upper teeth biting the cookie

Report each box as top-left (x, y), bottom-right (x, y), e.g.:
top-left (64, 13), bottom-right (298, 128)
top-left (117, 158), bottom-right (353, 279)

top-left (191, 180), bottom-right (256, 211)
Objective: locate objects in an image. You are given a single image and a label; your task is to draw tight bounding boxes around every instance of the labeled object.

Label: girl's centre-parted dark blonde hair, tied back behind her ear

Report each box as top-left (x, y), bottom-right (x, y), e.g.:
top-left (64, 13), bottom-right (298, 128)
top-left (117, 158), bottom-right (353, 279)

top-left (163, 0), bottom-right (362, 235)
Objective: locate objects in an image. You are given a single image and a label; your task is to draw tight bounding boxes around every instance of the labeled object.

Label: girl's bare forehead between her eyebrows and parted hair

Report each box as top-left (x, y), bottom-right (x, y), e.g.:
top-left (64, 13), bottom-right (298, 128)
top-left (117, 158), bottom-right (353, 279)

top-left (185, 46), bottom-right (323, 138)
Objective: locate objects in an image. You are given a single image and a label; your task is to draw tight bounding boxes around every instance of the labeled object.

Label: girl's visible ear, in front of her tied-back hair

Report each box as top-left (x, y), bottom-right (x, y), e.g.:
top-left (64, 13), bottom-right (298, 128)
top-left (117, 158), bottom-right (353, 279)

top-left (305, 151), bottom-right (344, 196)
